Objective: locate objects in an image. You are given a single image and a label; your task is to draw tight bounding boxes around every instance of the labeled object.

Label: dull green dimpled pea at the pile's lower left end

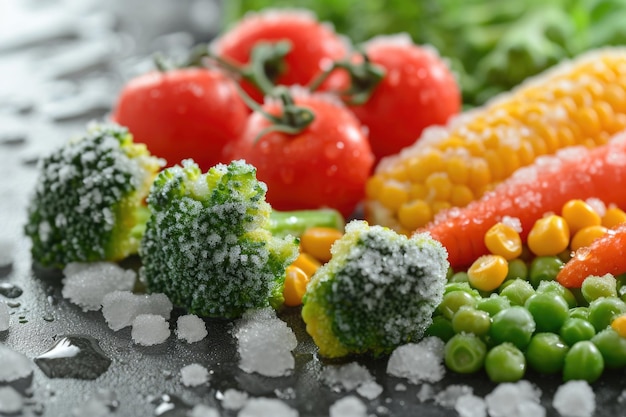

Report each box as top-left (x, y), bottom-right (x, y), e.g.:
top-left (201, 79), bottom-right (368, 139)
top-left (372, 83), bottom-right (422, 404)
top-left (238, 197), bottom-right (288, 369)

top-left (444, 333), bottom-right (487, 374)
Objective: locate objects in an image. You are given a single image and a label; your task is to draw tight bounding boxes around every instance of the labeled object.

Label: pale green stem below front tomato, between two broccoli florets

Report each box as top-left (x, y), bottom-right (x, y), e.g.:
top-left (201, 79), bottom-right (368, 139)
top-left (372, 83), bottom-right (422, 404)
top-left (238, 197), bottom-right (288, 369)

top-left (268, 209), bottom-right (345, 237)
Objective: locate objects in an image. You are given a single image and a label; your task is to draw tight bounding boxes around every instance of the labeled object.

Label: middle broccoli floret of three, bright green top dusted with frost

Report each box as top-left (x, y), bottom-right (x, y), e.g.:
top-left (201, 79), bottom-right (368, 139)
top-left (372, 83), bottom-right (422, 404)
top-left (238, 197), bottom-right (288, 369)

top-left (139, 160), bottom-right (298, 318)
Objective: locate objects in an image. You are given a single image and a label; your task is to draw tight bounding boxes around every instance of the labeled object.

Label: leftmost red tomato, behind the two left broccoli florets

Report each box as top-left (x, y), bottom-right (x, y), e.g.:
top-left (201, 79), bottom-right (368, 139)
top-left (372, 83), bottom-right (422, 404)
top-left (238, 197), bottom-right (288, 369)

top-left (112, 68), bottom-right (250, 171)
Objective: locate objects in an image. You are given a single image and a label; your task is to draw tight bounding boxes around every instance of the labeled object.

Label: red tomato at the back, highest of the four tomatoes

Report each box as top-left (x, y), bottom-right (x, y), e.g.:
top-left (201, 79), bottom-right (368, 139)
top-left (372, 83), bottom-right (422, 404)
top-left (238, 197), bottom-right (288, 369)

top-left (211, 9), bottom-right (349, 103)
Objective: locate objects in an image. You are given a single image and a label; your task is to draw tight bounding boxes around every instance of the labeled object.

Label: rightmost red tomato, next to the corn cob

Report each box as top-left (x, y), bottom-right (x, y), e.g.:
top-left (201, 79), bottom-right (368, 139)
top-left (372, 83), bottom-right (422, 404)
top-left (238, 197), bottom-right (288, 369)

top-left (350, 35), bottom-right (461, 160)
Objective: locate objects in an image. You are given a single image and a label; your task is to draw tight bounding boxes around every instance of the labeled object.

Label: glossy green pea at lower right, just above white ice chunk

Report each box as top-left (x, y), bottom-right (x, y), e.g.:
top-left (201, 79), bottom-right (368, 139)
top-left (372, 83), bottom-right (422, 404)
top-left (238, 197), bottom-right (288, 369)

top-left (563, 340), bottom-right (604, 383)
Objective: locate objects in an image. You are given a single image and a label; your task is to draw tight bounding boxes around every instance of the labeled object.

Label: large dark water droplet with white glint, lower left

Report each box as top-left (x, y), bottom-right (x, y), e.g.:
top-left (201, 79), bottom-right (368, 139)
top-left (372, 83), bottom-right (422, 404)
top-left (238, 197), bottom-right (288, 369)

top-left (34, 335), bottom-right (111, 379)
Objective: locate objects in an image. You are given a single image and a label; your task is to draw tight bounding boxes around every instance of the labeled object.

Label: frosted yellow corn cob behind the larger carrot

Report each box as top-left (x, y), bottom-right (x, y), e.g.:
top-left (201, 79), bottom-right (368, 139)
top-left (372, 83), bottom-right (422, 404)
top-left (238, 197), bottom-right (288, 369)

top-left (365, 47), bottom-right (626, 234)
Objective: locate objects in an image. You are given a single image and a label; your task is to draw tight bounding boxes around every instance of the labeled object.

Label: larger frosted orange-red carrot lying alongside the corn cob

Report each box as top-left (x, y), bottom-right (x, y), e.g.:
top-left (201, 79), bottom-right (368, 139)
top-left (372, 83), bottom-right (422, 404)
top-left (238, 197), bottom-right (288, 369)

top-left (418, 131), bottom-right (626, 268)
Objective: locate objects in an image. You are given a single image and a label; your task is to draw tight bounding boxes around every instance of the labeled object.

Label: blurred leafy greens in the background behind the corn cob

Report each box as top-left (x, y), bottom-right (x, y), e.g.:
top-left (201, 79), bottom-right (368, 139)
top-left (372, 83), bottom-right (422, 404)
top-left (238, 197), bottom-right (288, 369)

top-left (224, 0), bottom-right (626, 107)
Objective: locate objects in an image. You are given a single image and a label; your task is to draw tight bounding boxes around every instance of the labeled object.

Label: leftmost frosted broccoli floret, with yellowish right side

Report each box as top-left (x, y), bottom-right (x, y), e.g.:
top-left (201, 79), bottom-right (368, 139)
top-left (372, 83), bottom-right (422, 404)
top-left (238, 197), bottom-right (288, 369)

top-left (24, 123), bottom-right (163, 268)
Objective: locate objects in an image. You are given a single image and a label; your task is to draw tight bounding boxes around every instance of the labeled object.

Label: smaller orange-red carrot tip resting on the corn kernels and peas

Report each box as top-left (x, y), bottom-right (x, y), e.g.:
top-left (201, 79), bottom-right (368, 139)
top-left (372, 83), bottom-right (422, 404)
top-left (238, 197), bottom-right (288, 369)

top-left (556, 224), bottom-right (626, 288)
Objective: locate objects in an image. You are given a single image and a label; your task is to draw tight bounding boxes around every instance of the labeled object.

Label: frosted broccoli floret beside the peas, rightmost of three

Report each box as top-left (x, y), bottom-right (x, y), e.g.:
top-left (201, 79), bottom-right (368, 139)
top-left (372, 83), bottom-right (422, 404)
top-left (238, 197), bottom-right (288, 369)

top-left (302, 220), bottom-right (448, 358)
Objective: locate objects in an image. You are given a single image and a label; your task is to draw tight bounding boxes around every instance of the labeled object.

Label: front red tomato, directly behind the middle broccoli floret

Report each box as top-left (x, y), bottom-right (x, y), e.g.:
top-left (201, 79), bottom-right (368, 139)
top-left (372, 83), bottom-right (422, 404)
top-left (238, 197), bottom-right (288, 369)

top-left (227, 89), bottom-right (374, 217)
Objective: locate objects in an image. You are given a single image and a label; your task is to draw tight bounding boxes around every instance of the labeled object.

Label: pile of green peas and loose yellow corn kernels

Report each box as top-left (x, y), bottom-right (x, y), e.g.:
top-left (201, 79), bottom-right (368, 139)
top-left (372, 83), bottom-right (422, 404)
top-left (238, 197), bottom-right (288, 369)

top-left (427, 200), bottom-right (626, 382)
